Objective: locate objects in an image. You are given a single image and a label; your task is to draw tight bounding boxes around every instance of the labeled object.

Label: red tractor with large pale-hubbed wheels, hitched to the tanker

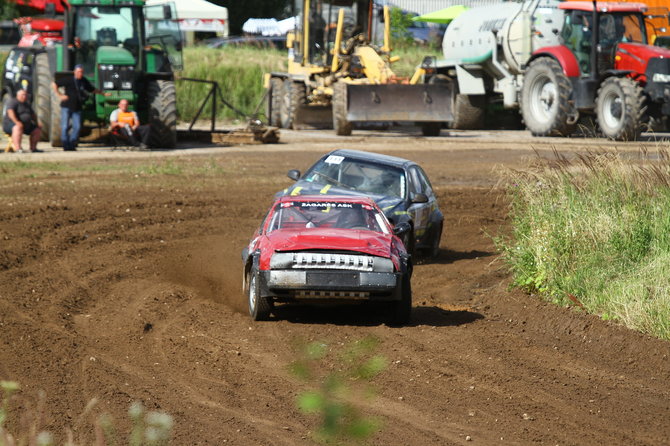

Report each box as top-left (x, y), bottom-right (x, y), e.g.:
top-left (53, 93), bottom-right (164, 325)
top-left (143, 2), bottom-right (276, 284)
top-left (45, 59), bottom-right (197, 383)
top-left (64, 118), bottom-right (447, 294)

top-left (520, 1), bottom-right (670, 140)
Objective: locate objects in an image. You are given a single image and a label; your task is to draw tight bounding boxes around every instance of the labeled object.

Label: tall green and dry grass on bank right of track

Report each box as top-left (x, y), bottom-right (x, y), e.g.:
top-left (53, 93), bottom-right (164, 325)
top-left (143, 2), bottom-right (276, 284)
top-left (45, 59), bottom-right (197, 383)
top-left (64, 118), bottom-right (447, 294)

top-left (497, 150), bottom-right (670, 339)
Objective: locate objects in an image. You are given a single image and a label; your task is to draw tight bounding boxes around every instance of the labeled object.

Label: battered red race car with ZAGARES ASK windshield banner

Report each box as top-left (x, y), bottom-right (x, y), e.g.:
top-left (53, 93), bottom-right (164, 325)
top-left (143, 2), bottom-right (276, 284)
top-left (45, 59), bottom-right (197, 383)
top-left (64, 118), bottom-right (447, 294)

top-left (242, 195), bottom-right (412, 325)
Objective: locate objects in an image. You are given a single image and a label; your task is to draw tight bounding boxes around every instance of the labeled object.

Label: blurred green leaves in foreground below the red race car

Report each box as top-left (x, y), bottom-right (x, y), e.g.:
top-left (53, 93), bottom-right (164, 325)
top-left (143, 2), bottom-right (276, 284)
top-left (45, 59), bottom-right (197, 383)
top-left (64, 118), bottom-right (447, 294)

top-left (290, 337), bottom-right (387, 444)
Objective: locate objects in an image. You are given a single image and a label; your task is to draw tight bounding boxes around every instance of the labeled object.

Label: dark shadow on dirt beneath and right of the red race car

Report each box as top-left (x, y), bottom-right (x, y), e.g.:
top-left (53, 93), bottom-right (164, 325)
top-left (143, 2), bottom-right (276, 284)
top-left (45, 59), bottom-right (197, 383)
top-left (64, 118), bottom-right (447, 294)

top-left (273, 304), bottom-right (484, 327)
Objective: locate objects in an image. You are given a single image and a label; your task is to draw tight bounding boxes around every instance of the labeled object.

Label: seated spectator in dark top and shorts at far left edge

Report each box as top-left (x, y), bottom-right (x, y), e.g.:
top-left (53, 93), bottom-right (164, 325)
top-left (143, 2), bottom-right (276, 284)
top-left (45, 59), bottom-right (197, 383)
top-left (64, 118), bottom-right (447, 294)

top-left (2, 90), bottom-right (42, 152)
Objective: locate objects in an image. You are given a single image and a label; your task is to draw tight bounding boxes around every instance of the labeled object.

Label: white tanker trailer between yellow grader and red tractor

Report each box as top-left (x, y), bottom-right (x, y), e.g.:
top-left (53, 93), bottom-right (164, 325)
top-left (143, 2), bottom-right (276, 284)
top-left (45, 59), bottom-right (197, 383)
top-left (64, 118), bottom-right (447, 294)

top-left (427, 0), bottom-right (563, 129)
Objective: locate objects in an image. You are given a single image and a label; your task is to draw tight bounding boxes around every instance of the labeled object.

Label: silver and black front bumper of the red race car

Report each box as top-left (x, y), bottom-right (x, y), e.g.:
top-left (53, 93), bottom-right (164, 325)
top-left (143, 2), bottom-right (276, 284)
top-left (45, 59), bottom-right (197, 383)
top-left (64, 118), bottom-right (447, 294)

top-left (261, 269), bottom-right (400, 300)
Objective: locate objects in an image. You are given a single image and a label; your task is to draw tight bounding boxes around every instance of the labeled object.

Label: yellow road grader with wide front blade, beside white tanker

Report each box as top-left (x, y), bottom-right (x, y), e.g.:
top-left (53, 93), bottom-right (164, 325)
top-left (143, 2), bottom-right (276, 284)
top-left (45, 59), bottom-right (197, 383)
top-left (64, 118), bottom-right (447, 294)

top-left (264, 0), bottom-right (453, 136)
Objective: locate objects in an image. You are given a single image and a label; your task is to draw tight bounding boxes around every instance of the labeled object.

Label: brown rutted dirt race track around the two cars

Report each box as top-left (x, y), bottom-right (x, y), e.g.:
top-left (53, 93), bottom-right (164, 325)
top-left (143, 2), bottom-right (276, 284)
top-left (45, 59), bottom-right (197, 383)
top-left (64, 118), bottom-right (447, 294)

top-left (0, 128), bottom-right (670, 445)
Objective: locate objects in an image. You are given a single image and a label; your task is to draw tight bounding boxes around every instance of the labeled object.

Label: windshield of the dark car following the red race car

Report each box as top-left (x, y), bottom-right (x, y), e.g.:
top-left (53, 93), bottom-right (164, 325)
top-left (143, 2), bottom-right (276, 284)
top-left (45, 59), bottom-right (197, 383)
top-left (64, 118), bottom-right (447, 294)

top-left (305, 155), bottom-right (406, 198)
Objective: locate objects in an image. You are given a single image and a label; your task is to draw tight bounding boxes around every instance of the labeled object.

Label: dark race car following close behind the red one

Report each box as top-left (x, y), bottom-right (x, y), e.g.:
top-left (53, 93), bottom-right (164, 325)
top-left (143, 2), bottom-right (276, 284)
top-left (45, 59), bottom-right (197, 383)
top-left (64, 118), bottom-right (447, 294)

top-left (277, 150), bottom-right (444, 257)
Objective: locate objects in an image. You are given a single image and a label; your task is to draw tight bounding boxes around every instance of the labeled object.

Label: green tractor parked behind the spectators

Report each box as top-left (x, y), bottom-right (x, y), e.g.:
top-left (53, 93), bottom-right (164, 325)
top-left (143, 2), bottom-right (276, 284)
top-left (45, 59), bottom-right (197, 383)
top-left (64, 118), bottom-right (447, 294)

top-left (16, 0), bottom-right (182, 148)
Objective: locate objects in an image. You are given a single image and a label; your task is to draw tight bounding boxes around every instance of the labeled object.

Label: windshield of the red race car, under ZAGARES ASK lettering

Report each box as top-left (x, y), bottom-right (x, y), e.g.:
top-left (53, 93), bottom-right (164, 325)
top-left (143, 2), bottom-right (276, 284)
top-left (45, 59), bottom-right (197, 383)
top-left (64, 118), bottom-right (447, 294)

top-left (268, 201), bottom-right (389, 234)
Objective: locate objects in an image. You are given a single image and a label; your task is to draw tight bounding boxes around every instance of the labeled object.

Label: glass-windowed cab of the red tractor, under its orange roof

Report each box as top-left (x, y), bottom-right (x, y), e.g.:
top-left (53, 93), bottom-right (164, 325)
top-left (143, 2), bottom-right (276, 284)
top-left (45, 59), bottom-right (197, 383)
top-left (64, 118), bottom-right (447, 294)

top-left (559, 1), bottom-right (647, 76)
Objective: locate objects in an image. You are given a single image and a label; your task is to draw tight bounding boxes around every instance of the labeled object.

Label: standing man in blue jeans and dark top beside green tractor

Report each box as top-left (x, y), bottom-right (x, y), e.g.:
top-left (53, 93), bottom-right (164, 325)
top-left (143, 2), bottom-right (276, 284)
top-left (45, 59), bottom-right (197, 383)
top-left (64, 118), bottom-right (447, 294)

top-left (51, 65), bottom-right (111, 150)
